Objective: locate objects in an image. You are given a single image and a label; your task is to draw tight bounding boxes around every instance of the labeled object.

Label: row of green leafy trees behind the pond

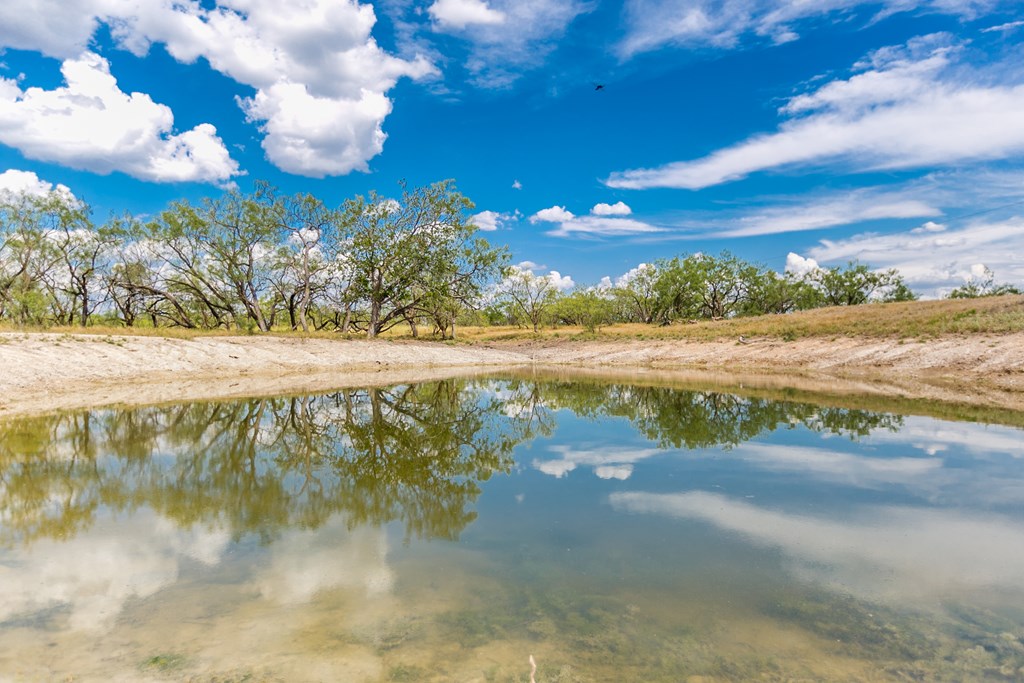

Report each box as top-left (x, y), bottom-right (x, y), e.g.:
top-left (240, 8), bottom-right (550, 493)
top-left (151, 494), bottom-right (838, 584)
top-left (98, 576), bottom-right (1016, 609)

top-left (6, 180), bottom-right (1005, 339)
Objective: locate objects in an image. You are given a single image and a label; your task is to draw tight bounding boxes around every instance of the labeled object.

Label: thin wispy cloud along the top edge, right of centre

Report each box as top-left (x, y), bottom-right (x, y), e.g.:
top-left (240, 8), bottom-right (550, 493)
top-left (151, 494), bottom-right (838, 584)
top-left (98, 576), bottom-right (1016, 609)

top-left (616, 0), bottom-right (999, 57)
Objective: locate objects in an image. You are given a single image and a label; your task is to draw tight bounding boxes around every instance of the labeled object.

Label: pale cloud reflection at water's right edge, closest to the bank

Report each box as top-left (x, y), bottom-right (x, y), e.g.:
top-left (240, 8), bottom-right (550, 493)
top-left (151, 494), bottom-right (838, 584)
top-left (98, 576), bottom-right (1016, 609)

top-left (866, 417), bottom-right (1024, 458)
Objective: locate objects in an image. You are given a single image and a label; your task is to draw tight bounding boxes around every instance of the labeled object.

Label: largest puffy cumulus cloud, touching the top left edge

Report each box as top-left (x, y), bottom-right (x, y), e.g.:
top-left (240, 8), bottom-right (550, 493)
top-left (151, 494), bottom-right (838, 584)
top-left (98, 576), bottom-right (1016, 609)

top-left (0, 0), bottom-right (436, 177)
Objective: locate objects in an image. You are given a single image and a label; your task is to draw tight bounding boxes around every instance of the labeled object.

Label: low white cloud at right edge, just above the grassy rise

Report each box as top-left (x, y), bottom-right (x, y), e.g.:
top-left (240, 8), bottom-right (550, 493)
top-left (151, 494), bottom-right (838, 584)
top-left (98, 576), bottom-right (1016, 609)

top-left (808, 217), bottom-right (1024, 297)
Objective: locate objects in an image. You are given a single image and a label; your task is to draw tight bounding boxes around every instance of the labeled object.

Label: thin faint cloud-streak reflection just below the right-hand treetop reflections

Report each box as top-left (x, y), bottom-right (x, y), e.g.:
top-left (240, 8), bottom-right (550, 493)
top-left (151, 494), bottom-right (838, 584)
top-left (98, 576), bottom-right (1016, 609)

top-left (733, 443), bottom-right (942, 487)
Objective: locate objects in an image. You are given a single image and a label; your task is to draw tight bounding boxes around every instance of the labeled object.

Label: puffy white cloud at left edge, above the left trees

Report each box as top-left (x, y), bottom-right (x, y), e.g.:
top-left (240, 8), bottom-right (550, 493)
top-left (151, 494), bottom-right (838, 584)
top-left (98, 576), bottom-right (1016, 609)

top-left (0, 52), bottom-right (239, 182)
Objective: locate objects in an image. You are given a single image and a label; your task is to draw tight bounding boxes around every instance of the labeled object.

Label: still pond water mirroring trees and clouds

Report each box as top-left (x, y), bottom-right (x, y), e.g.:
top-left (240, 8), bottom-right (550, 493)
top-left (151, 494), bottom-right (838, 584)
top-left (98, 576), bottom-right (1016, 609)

top-left (0, 378), bottom-right (1024, 683)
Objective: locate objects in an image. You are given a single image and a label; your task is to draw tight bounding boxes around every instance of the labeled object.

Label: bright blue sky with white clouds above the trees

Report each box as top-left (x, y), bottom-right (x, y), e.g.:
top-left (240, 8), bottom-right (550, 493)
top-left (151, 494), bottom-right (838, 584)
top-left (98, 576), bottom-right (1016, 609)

top-left (0, 0), bottom-right (1024, 297)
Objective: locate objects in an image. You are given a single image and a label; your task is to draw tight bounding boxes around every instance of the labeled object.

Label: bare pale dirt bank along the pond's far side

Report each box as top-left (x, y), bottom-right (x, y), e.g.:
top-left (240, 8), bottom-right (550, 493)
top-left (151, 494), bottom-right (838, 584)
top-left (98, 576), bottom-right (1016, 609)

top-left (0, 333), bottom-right (1024, 417)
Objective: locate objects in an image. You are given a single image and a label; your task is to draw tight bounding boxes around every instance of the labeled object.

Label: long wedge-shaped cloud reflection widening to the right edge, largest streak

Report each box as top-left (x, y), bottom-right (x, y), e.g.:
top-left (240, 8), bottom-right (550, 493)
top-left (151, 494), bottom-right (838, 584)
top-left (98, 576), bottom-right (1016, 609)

top-left (610, 492), bottom-right (1024, 598)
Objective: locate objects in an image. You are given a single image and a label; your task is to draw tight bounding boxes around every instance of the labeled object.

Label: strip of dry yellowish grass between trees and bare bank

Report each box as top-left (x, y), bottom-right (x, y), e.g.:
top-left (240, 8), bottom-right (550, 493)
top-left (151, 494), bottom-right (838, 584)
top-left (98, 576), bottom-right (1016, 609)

top-left (0, 295), bottom-right (1024, 344)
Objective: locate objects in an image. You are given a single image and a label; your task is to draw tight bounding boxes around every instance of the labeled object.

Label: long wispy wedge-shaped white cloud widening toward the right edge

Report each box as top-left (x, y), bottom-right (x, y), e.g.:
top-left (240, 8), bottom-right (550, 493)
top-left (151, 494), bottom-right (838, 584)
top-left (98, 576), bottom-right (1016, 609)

top-left (606, 36), bottom-right (1024, 189)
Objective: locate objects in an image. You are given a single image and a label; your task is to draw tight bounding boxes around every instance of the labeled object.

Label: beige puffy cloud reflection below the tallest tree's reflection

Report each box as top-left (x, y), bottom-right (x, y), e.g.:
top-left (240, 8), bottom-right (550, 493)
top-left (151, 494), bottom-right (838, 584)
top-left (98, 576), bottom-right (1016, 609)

top-left (256, 517), bottom-right (394, 604)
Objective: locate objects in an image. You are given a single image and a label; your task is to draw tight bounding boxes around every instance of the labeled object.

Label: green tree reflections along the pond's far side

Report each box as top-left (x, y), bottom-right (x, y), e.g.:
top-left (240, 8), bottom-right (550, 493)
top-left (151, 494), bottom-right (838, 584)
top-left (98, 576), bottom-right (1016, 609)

top-left (0, 380), bottom-right (900, 545)
